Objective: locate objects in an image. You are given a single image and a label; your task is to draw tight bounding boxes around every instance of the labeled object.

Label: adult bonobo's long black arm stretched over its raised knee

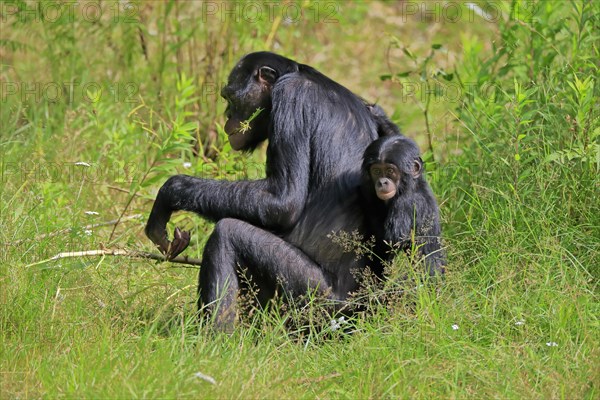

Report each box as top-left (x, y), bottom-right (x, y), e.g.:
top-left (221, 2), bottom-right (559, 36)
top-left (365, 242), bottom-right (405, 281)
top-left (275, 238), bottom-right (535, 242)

top-left (146, 85), bottom-right (311, 258)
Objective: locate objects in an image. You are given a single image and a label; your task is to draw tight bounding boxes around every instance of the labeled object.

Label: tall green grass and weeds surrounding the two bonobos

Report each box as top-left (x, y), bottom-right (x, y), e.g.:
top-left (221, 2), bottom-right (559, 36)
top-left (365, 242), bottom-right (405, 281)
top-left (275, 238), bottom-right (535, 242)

top-left (0, 1), bottom-right (600, 399)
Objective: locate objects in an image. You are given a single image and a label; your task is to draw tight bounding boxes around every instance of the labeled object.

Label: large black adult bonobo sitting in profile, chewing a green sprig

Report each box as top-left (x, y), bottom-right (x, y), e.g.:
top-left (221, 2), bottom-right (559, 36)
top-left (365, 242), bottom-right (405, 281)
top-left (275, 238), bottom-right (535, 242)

top-left (146, 52), bottom-right (386, 328)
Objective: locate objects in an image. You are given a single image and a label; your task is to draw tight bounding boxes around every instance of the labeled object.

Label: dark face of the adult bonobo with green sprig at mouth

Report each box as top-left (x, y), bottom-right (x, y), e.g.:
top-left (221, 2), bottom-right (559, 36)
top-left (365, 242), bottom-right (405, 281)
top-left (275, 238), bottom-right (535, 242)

top-left (221, 53), bottom-right (278, 150)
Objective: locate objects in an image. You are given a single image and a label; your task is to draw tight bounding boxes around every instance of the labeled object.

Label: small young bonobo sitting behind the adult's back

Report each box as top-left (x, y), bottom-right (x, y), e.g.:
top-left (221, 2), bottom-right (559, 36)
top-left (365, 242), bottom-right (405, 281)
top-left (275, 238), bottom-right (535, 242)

top-left (361, 134), bottom-right (446, 276)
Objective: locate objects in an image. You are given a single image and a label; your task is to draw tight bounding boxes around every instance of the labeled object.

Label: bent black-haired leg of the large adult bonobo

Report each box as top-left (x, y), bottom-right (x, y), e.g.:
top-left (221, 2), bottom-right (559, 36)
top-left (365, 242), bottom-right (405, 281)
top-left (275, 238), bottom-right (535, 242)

top-left (198, 218), bottom-right (332, 329)
